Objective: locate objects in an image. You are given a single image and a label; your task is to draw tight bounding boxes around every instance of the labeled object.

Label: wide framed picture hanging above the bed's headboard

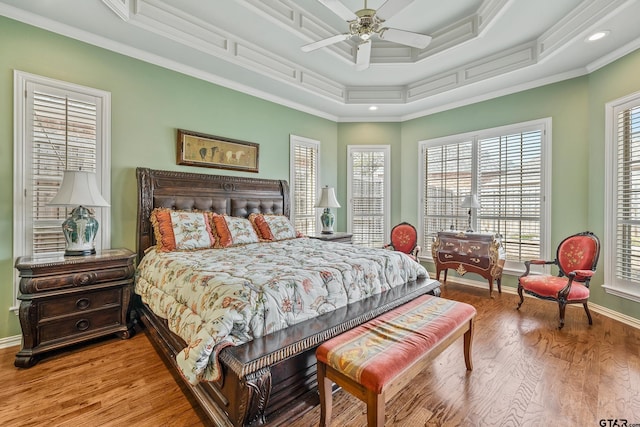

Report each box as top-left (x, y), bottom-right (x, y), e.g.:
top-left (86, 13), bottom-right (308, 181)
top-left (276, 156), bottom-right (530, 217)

top-left (177, 129), bottom-right (260, 172)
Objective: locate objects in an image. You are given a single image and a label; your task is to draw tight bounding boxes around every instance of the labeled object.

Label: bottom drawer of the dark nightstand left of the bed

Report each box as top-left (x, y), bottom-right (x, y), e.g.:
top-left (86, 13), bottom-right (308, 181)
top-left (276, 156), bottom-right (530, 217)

top-left (38, 306), bottom-right (122, 345)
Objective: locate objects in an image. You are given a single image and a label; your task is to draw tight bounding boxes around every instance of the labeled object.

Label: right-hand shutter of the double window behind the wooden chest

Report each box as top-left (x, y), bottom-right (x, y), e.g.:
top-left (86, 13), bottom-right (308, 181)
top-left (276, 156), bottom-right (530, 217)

top-left (478, 129), bottom-right (543, 261)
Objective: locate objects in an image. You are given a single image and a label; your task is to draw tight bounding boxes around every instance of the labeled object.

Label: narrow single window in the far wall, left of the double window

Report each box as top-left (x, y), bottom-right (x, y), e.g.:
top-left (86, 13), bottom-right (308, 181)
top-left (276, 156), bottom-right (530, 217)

top-left (347, 145), bottom-right (391, 248)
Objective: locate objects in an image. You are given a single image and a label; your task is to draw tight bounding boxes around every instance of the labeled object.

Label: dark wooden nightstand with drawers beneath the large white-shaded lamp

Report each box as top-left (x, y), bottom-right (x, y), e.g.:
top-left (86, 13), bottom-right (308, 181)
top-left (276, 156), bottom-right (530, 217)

top-left (14, 249), bottom-right (136, 368)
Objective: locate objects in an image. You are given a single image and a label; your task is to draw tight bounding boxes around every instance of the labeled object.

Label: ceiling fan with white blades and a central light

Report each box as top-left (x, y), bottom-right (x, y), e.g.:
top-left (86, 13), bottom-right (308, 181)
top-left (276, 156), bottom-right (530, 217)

top-left (302, 0), bottom-right (431, 70)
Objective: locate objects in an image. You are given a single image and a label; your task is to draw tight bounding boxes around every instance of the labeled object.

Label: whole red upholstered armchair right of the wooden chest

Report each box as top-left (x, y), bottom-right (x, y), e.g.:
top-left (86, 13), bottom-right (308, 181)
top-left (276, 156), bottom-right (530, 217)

top-left (518, 231), bottom-right (600, 329)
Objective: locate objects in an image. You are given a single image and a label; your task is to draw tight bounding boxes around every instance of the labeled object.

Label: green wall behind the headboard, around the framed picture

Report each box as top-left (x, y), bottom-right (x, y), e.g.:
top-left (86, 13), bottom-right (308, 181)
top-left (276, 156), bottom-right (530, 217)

top-left (0, 17), bottom-right (344, 338)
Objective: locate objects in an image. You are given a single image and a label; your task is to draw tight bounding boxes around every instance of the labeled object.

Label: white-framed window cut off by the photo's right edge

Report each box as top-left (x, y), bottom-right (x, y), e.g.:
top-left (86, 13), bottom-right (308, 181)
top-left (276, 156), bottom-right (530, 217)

top-left (604, 93), bottom-right (640, 302)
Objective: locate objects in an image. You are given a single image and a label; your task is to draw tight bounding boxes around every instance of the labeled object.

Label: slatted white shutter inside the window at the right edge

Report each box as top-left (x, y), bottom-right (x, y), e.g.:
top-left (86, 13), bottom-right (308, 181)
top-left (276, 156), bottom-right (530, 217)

top-left (615, 105), bottom-right (640, 283)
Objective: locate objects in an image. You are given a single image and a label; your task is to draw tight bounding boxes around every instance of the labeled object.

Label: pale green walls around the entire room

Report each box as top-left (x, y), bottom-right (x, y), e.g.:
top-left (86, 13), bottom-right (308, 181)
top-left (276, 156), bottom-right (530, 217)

top-left (0, 17), bottom-right (640, 339)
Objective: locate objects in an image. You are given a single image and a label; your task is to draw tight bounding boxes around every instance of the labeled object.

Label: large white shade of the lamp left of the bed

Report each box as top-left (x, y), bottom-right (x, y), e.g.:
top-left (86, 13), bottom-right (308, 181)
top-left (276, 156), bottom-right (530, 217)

top-left (49, 171), bottom-right (109, 207)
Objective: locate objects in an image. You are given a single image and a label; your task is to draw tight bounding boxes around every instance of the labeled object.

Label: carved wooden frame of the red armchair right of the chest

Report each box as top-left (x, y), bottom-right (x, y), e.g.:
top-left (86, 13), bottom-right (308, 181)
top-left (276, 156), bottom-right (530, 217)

top-left (517, 231), bottom-right (600, 329)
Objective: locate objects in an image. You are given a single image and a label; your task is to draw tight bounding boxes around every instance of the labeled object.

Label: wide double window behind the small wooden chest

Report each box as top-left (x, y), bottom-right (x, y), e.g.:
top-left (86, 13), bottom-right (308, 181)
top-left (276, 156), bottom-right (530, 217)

top-left (420, 119), bottom-right (551, 270)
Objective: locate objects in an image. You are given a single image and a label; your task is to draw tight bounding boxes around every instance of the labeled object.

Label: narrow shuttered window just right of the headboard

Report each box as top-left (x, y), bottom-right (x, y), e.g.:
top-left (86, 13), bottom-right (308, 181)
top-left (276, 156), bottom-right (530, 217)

top-left (289, 135), bottom-right (320, 235)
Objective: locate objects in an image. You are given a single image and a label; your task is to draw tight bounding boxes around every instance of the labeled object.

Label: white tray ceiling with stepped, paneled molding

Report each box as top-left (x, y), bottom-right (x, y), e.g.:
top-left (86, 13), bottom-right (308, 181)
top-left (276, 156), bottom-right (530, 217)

top-left (0, 0), bottom-right (640, 121)
